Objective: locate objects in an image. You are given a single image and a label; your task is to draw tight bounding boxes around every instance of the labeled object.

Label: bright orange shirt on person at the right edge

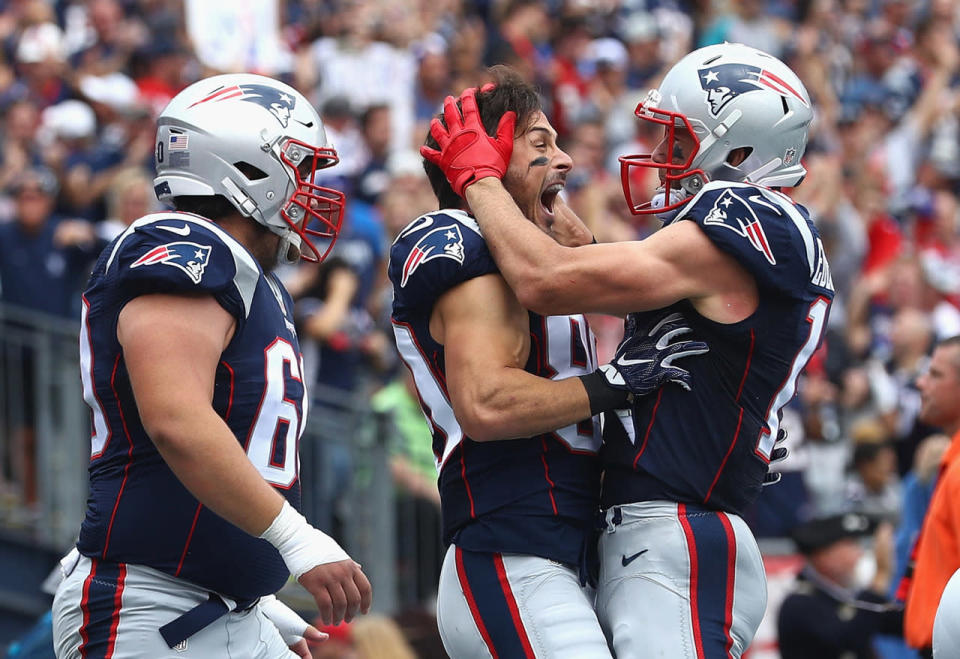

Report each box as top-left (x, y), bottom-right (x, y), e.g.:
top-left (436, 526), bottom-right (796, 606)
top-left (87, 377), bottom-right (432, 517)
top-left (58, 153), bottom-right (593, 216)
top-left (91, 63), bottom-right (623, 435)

top-left (903, 432), bottom-right (960, 648)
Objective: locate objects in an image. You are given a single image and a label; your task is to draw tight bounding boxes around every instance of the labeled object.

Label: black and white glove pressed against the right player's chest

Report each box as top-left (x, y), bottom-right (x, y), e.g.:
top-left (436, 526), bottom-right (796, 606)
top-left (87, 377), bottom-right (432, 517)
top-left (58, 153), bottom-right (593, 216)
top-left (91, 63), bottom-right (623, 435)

top-left (580, 313), bottom-right (710, 414)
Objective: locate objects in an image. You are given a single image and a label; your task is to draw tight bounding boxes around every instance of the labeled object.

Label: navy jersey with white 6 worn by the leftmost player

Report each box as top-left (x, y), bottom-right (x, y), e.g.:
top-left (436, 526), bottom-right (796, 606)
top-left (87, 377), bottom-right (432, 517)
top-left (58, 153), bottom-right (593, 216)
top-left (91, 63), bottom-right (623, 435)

top-left (77, 213), bottom-right (307, 599)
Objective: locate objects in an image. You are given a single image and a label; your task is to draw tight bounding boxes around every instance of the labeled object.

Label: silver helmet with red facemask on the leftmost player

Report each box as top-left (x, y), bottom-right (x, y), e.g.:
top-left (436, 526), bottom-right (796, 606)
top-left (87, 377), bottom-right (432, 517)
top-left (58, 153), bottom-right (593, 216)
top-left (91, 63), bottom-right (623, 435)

top-left (154, 73), bottom-right (344, 263)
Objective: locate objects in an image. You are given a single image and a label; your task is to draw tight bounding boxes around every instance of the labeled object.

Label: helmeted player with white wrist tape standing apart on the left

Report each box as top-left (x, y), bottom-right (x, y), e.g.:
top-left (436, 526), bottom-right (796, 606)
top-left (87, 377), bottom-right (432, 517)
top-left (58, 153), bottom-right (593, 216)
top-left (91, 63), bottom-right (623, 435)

top-left (53, 74), bottom-right (371, 658)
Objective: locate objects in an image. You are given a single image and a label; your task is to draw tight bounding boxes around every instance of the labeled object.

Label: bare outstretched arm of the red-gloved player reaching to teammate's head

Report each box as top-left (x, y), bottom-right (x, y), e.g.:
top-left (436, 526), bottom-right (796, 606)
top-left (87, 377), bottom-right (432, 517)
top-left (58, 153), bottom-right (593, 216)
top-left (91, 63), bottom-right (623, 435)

top-left (465, 177), bottom-right (757, 322)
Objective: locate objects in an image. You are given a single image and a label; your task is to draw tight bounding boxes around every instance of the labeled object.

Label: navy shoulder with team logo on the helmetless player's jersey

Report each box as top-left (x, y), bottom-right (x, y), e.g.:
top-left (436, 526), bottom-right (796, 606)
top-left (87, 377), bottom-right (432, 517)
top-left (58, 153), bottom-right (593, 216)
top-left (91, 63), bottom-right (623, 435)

top-left (388, 210), bottom-right (498, 304)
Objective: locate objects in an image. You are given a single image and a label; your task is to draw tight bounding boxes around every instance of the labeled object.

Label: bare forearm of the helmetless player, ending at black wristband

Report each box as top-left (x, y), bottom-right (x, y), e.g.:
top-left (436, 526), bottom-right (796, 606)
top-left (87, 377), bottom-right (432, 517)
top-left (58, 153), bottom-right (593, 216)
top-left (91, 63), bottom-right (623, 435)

top-left (451, 368), bottom-right (590, 441)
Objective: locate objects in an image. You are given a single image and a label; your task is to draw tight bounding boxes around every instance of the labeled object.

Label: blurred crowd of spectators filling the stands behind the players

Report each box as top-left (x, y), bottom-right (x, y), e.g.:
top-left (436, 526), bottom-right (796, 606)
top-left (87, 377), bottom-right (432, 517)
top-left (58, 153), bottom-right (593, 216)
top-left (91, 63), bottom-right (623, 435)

top-left (0, 0), bottom-right (960, 656)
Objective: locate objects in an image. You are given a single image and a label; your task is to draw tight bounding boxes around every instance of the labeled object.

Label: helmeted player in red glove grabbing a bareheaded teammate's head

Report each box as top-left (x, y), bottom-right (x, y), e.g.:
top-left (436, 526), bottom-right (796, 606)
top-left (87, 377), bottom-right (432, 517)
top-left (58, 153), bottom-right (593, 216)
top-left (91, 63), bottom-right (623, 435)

top-left (425, 43), bottom-right (834, 659)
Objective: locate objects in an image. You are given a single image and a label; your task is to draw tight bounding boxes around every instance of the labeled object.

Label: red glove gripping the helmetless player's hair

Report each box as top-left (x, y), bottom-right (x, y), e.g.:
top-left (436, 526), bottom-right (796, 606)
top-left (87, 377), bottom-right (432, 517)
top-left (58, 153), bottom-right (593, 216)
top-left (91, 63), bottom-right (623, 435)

top-left (420, 87), bottom-right (517, 197)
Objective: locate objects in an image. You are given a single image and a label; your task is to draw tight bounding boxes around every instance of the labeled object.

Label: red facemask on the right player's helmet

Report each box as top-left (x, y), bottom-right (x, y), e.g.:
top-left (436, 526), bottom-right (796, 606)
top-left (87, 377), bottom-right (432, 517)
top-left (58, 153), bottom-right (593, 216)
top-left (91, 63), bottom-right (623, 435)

top-left (619, 101), bottom-right (707, 215)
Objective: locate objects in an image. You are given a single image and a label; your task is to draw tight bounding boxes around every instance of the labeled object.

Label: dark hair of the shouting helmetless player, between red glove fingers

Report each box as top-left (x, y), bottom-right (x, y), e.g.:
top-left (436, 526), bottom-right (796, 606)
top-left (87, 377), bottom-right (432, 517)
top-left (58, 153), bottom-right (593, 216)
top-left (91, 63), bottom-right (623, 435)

top-left (423, 65), bottom-right (542, 208)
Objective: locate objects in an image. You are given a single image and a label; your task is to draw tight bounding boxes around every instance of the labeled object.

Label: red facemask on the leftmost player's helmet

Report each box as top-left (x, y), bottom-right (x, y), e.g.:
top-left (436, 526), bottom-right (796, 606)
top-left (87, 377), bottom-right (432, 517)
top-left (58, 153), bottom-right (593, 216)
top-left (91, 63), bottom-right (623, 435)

top-left (279, 139), bottom-right (346, 263)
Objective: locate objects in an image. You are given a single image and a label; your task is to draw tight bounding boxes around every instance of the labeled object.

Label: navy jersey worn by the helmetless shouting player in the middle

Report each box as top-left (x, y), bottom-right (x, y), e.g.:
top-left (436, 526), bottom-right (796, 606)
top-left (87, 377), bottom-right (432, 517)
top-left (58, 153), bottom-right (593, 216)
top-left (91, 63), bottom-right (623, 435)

top-left (389, 210), bottom-right (600, 564)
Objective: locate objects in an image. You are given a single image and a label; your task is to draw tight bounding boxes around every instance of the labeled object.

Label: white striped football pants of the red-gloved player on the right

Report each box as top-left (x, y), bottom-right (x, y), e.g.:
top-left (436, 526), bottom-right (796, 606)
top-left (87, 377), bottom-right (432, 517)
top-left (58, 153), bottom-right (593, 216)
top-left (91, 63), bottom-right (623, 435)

top-left (597, 501), bottom-right (767, 659)
